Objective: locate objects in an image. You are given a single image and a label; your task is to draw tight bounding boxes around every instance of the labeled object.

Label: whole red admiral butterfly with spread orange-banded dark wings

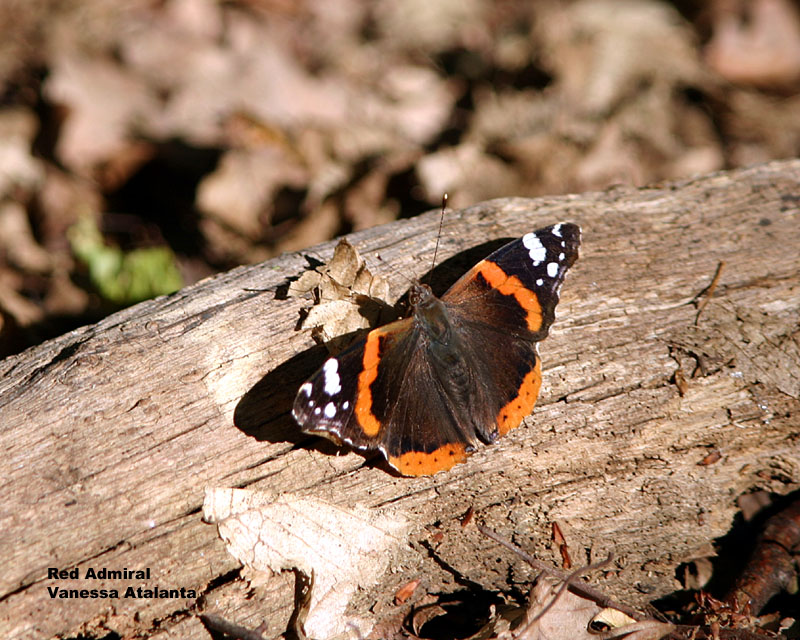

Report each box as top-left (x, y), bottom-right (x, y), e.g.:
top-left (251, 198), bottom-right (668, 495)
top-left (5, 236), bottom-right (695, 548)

top-left (292, 222), bottom-right (580, 476)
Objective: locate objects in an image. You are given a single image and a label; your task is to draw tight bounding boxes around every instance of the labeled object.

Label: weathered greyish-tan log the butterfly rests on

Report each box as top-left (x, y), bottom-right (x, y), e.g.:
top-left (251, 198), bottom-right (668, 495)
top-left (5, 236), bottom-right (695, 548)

top-left (0, 160), bottom-right (800, 639)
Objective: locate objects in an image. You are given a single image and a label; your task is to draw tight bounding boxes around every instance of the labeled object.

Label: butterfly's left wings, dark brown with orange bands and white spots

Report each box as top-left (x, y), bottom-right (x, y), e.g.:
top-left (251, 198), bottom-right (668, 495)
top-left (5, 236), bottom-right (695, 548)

top-left (292, 318), bottom-right (474, 475)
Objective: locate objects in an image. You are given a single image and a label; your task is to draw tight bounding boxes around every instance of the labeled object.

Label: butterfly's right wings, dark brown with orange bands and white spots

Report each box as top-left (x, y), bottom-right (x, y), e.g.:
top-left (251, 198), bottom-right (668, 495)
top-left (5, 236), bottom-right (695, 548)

top-left (442, 223), bottom-right (580, 441)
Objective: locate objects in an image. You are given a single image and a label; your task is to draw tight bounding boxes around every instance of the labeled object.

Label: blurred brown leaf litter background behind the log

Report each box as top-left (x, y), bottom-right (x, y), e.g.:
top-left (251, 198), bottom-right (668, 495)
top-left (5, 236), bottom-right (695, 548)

top-left (0, 0), bottom-right (800, 357)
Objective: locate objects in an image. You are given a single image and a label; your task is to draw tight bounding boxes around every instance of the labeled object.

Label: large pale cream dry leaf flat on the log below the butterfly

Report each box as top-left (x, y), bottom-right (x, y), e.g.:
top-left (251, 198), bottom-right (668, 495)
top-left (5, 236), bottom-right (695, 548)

top-left (203, 488), bottom-right (410, 638)
